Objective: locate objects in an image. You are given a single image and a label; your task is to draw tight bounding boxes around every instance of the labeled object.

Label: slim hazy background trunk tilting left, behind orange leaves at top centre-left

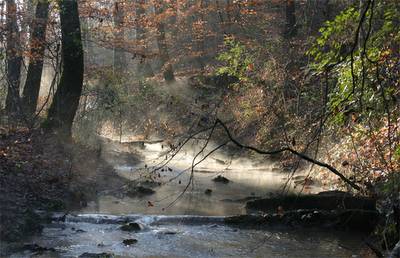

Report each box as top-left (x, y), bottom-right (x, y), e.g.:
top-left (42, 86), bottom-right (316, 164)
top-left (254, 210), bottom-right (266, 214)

top-left (154, 1), bottom-right (175, 83)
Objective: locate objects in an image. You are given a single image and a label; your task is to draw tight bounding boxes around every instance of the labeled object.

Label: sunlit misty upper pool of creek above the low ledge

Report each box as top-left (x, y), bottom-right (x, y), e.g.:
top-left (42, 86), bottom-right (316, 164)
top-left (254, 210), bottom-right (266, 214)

top-left (83, 139), bottom-right (319, 215)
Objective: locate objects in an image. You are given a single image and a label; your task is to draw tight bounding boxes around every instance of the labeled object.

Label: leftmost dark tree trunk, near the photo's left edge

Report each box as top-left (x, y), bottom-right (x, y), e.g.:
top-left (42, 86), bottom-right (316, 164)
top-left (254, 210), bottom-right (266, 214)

top-left (6, 0), bottom-right (22, 118)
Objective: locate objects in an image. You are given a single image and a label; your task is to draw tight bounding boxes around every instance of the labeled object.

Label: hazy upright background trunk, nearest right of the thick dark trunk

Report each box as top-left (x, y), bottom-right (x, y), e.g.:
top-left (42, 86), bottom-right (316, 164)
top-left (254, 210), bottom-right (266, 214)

top-left (113, 1), bottom-right (126, 74)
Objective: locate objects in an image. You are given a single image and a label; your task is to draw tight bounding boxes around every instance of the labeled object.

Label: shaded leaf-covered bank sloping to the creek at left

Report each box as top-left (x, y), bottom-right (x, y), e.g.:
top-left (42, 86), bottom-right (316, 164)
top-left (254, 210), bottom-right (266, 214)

top-left (0, 128), bottom-right (124, 241)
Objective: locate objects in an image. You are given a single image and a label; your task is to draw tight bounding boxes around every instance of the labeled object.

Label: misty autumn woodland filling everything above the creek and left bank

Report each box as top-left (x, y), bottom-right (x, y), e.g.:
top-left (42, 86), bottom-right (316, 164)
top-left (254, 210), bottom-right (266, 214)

top-left (0, 0), bottom-right (400, 256)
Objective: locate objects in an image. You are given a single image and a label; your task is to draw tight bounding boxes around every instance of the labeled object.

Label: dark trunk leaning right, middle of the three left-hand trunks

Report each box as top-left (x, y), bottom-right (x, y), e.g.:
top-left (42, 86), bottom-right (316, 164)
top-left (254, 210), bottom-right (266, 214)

top-left (22, 0), bottom-right (49, 117)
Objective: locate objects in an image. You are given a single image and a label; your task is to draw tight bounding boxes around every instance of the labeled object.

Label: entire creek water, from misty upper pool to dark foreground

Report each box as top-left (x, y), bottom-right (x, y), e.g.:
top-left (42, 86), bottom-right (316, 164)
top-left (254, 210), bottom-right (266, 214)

top-left (3, 138), bottom-right (363, 257)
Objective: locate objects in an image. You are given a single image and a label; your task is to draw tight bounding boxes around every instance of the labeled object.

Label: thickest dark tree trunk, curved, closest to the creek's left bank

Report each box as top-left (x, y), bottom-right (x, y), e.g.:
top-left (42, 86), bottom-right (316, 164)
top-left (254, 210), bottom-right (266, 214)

top-left (46, 0), bottom-right (84, 137)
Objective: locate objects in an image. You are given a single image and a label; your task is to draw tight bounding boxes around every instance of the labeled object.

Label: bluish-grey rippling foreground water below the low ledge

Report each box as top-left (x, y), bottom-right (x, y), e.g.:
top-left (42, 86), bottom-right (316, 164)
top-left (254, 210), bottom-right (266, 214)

top-left (7, 214), bottom-right (368, 257)
